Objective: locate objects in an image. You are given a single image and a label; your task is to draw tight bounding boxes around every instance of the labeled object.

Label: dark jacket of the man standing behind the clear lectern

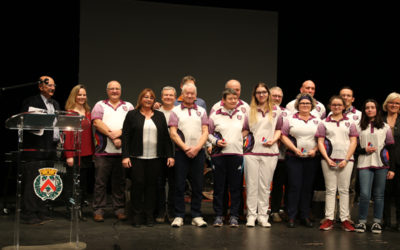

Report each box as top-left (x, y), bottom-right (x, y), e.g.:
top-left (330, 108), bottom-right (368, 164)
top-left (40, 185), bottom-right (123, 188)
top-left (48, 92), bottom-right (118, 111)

top-left (21, 94), bottom-right (60, 159)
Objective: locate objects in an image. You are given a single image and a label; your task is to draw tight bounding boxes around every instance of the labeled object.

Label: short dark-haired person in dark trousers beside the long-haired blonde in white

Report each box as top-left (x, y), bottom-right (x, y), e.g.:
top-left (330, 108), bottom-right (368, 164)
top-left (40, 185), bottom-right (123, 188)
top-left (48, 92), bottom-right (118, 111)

top-left (208, 88), bottom-right (248, 227)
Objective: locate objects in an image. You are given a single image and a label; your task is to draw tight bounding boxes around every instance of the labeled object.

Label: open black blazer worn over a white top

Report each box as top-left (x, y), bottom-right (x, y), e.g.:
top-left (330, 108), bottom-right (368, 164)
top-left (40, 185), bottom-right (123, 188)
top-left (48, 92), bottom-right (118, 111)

top-left (122, 109), bottom-right (174, 158)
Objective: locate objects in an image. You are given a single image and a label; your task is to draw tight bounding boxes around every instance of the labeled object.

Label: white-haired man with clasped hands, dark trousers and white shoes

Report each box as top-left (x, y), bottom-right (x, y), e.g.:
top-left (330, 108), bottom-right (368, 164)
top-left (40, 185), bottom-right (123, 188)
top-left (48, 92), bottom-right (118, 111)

top-left (168, 83), bottom-right (208, 227)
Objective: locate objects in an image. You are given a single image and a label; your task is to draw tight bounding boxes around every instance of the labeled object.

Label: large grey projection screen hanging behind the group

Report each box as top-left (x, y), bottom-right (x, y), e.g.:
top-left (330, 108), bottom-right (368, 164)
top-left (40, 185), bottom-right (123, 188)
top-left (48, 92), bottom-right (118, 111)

top-left (79, 0), bottom-right (278, 109)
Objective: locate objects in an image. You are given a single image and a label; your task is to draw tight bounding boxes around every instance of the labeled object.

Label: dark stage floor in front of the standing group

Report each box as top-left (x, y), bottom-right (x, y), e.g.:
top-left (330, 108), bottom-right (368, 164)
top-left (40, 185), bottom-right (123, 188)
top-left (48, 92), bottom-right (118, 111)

top-left (0, 198), bottom-right (400, 250)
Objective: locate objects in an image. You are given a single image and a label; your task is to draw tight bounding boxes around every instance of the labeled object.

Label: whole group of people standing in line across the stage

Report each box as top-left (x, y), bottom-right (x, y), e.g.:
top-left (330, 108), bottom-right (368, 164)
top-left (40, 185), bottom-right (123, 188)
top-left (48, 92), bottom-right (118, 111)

top-left (19, 76), bottom-right (400, 233)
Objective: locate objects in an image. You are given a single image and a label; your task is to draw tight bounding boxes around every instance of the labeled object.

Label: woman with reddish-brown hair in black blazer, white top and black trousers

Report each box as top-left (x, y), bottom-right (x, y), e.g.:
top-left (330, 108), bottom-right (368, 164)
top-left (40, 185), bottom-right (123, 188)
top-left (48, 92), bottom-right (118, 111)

top-left (122, 88), bottom-right (175, 226)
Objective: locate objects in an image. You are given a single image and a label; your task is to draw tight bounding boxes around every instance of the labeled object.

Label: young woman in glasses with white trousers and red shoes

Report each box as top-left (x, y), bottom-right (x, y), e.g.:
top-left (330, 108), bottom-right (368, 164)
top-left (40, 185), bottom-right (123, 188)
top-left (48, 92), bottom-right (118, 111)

top-left (315, 96), bottom-right (358, 232)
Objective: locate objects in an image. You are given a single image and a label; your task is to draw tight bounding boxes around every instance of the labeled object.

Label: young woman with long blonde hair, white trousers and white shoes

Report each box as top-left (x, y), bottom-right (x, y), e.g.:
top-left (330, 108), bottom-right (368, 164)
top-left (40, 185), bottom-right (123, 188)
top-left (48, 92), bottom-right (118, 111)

top-left (244, 83), bottom-right (282, 227)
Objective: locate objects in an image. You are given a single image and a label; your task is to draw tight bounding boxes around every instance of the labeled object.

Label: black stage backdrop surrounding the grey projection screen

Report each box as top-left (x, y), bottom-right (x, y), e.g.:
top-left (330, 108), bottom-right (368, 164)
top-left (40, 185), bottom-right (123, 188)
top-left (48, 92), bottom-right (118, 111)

top-left (0, 0), bottom-right (400, 195)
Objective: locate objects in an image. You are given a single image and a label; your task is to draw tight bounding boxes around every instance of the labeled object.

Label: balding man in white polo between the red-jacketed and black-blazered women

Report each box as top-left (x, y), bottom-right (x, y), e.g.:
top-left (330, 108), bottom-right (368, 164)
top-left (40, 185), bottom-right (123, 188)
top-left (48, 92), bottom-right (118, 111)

top-left (92, 81), bottom-right (133, 222)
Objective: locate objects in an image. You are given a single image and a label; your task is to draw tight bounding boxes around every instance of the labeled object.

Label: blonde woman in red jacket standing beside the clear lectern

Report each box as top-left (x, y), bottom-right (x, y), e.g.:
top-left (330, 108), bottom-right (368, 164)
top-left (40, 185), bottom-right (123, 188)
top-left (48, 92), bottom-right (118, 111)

top-left (64, 84), bottom-right (94, 220)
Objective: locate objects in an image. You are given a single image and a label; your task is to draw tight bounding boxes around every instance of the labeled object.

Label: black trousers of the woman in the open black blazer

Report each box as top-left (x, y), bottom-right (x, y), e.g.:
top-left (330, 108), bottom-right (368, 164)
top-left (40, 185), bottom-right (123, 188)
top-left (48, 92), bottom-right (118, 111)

top-left (131, 158), bottom-right (163, 219)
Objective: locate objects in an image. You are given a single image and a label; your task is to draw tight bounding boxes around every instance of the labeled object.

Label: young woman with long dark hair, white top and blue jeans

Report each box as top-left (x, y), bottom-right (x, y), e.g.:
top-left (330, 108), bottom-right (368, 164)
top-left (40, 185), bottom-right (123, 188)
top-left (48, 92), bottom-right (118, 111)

top-left (355, 99), bottom-right (394, 233)
